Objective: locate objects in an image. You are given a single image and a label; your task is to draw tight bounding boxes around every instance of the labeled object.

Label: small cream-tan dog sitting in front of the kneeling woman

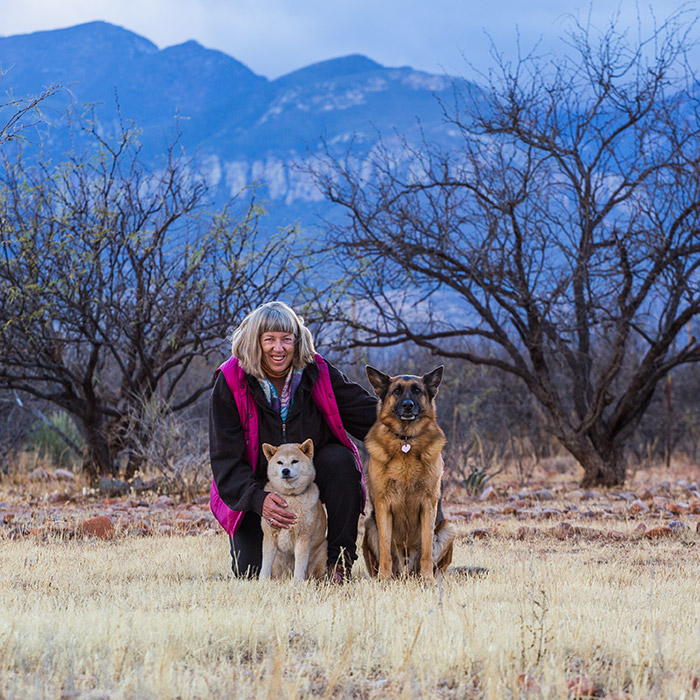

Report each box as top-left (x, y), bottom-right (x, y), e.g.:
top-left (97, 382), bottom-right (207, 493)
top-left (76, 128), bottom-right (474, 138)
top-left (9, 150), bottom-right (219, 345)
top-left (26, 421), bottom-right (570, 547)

top-left (260, 439), bottom-right (328, 581)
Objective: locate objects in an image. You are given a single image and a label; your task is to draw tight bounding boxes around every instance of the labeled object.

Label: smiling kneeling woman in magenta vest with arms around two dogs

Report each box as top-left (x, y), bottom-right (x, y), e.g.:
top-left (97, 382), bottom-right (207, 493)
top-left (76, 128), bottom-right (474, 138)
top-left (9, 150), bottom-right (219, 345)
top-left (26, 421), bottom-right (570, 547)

top-left (209, 301), bottom-right (376, 582)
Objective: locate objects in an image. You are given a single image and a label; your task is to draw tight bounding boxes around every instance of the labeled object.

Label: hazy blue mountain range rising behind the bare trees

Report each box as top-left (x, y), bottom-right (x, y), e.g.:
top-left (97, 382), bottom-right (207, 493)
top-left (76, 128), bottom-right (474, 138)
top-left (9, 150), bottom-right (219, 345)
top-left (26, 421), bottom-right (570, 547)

top-left (0, 22), bottom-right (464, 227)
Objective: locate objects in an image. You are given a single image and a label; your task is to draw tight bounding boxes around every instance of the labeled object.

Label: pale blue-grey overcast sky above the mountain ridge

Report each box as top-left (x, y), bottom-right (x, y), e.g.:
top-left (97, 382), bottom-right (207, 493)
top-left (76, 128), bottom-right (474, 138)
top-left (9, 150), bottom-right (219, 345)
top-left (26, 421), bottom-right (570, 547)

top-left (0, 0), bottom-right (698, 78)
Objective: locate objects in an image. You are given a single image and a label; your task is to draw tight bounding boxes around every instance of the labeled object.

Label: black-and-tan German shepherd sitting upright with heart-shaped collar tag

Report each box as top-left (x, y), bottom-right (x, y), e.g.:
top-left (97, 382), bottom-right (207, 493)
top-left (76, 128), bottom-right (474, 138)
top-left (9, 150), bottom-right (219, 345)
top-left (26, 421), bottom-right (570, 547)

top-left (362, 365), bottom-right (456, 579)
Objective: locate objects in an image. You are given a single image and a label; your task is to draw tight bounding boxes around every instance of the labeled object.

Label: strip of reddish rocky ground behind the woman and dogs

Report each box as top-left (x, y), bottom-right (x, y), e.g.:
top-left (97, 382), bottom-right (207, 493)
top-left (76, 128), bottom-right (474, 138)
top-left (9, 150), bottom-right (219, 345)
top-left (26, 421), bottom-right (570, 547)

top-left (0, 469), bottom-right (700, 542)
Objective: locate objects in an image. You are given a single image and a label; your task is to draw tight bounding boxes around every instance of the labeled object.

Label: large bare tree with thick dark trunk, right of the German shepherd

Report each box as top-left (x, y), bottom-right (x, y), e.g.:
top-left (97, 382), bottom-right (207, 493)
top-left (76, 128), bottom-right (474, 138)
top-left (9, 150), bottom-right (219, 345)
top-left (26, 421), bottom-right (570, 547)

top-left (317, 13), bottom-right (700, 485)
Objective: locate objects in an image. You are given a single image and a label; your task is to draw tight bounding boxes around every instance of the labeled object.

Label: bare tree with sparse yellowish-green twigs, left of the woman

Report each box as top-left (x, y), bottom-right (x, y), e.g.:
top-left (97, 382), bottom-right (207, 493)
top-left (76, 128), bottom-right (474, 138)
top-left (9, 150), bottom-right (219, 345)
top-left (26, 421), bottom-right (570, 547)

top-left (0, 119), bottom-right (304, 477)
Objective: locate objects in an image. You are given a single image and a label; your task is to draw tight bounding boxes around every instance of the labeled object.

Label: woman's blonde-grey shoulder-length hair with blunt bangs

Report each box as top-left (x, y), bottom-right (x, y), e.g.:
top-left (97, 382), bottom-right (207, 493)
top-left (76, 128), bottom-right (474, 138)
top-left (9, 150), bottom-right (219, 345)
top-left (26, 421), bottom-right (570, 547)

top-left (231, 301), bottom-right (316, 379)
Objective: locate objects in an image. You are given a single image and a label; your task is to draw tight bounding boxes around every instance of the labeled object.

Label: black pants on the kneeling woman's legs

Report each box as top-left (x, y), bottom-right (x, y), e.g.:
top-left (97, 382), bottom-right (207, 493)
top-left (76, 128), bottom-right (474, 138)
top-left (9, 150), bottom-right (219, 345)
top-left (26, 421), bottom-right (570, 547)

top-left (230, 444), bottom-right (362, 577)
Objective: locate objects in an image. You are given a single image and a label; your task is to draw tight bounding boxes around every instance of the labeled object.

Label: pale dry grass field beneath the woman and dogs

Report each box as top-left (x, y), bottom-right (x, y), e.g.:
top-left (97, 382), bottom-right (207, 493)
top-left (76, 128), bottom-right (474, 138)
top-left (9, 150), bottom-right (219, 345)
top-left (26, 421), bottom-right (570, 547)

top-left (0, 462), bottom-right (700, 700)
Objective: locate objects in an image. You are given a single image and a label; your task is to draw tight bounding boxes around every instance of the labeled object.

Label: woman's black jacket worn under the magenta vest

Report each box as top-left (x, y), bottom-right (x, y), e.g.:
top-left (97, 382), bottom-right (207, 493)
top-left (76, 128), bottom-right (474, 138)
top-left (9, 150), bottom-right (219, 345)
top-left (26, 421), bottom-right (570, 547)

top-left (209, 362), bottom-right (377, 514)
